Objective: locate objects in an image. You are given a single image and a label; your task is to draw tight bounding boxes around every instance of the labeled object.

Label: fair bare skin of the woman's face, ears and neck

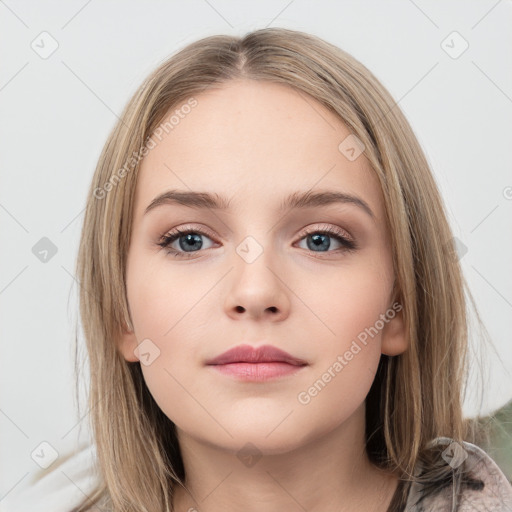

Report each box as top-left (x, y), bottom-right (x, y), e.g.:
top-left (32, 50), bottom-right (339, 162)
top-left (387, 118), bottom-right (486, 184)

top-left (119, 80), bottom-right (408, 512)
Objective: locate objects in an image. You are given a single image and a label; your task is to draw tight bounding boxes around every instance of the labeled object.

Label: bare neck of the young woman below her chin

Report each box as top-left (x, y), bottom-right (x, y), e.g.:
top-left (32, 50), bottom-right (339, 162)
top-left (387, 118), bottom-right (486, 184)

top-left (174, 403), bottom-right (398, 512)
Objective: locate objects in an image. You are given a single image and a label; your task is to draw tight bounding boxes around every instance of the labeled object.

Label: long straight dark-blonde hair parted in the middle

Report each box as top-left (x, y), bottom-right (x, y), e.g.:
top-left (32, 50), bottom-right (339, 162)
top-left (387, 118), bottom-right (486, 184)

top-left (72, 28), bottom-right (492, 512)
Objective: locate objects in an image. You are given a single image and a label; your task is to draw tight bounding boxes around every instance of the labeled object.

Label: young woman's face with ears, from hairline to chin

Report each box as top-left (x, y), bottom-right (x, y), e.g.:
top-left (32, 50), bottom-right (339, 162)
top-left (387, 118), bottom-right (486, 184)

top-left (119, 80), bottom-right (407, 453)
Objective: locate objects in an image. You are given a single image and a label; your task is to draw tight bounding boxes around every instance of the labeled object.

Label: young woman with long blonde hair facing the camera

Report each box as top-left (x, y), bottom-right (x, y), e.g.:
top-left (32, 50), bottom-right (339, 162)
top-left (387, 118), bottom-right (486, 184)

top-left (67, 28), bottom-right (512, 512)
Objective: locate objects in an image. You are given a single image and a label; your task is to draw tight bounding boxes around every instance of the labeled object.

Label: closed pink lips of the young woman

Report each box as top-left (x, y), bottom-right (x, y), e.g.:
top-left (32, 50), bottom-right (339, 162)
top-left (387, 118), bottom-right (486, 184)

top-left (206, 345), bottom-right (307, 381)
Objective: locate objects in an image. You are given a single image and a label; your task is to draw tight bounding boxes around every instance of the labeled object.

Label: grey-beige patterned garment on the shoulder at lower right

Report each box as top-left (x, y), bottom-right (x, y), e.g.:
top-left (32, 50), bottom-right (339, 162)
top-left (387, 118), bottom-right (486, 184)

top-left (405, 437), bottom-right (512, 512)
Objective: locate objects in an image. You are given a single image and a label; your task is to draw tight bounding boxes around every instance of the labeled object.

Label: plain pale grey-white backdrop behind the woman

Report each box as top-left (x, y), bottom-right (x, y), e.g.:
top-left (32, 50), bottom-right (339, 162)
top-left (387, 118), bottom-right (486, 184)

top-left (0, 0), bottom-right (512, 501)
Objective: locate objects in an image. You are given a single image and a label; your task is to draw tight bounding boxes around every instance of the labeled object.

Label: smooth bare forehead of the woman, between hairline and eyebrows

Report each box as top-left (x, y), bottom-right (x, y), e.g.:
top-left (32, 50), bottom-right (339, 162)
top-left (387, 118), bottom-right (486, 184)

top-left (135, 80), bottom-right (382, 222)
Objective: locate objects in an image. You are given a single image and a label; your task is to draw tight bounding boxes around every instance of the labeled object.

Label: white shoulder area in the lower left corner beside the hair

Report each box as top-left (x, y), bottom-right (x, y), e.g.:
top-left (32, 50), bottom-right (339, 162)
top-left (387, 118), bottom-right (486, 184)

top-left (0, 444), bottom-right (98, 512)
